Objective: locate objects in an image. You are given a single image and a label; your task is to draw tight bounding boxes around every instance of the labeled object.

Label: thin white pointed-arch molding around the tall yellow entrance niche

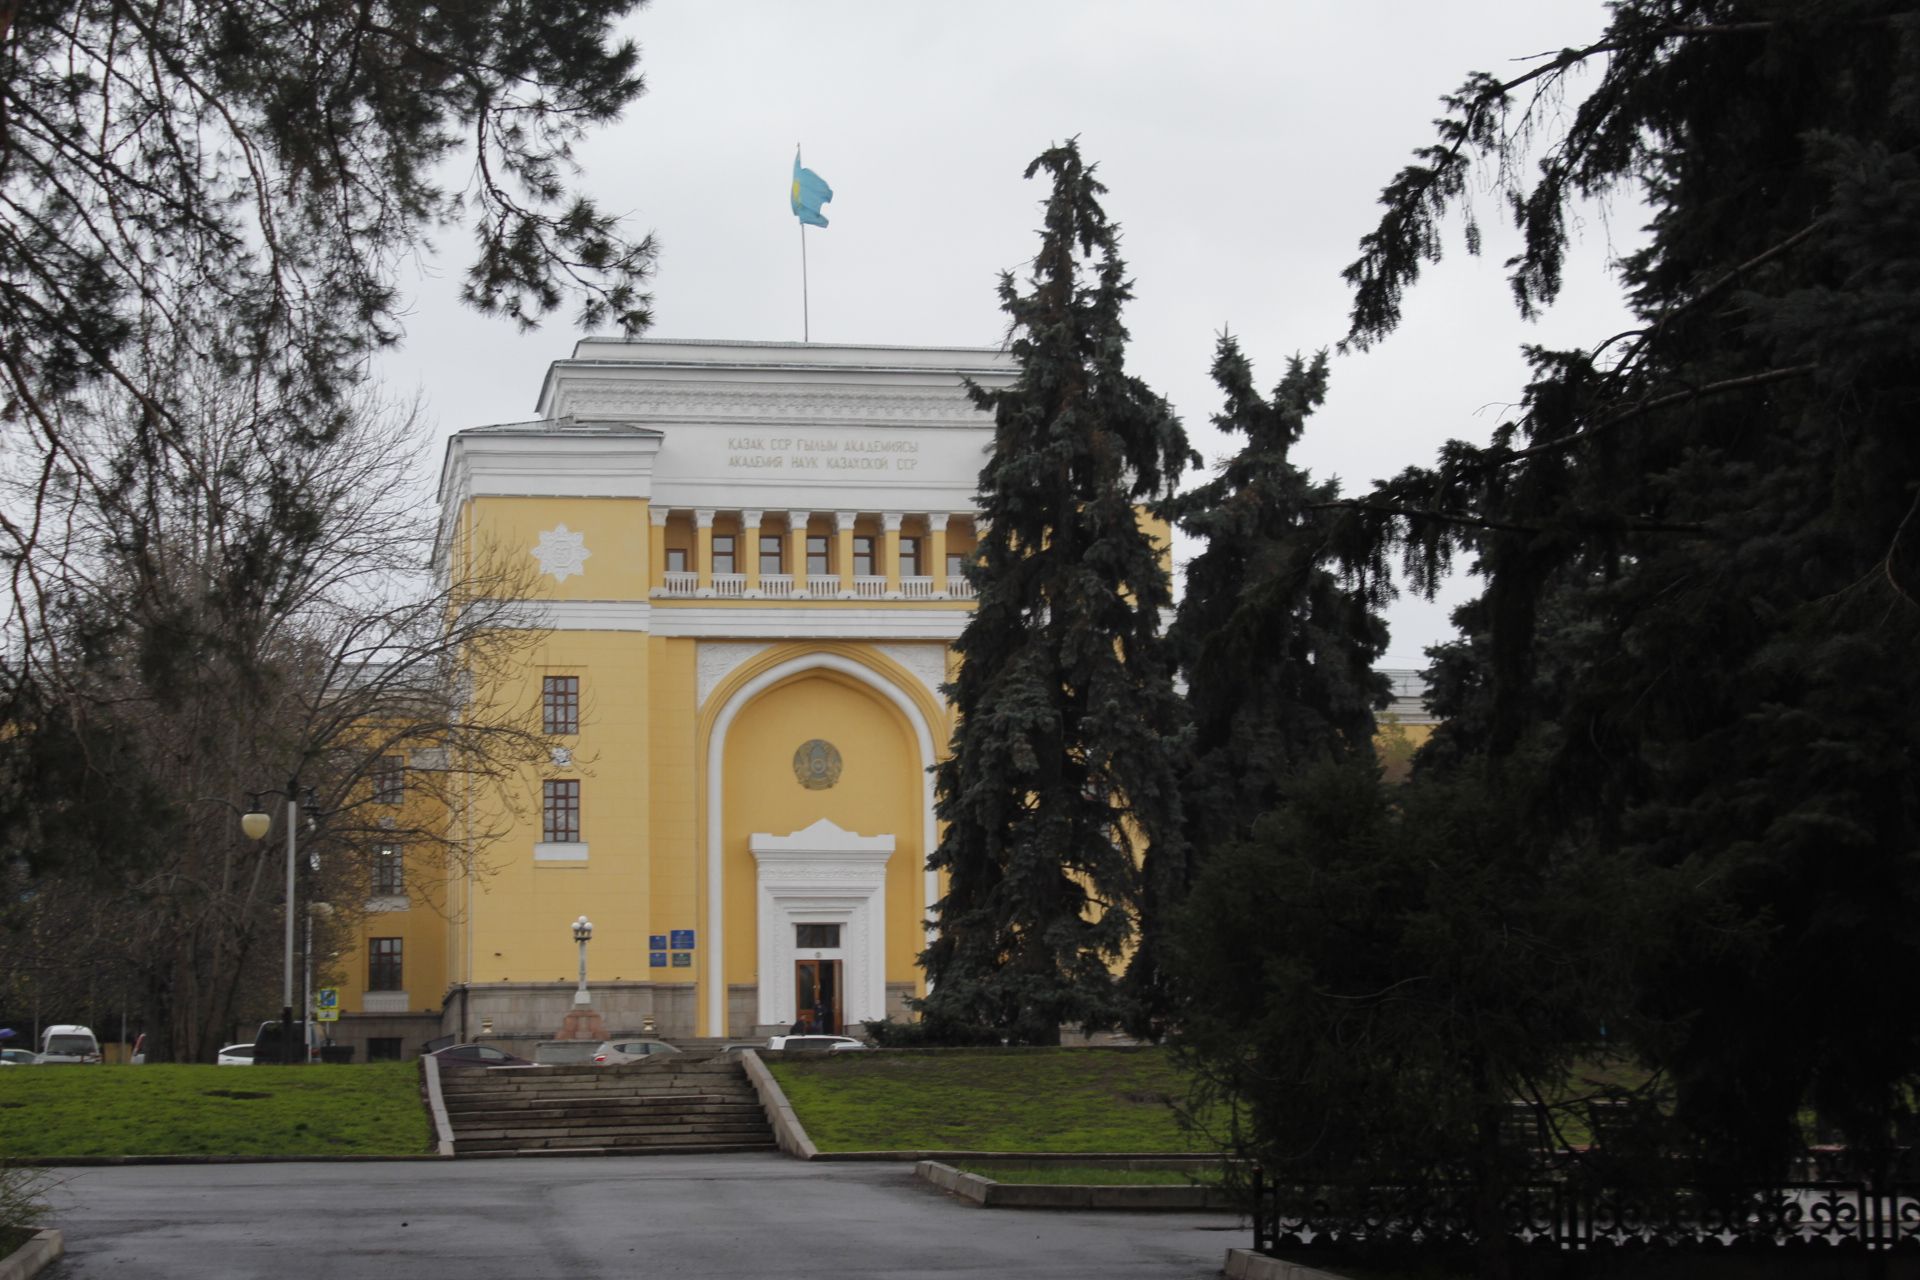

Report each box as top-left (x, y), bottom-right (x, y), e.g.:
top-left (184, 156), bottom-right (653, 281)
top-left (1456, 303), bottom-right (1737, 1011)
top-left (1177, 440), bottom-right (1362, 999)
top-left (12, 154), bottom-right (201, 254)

top-left (701, 652), bottom-right (939, 1036)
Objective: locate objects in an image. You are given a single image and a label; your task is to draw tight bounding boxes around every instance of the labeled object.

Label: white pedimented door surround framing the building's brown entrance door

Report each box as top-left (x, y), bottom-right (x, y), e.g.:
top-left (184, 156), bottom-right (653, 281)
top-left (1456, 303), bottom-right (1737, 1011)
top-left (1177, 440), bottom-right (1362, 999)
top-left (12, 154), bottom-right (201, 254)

top-left (747, 818), bottom-right (893, 1025)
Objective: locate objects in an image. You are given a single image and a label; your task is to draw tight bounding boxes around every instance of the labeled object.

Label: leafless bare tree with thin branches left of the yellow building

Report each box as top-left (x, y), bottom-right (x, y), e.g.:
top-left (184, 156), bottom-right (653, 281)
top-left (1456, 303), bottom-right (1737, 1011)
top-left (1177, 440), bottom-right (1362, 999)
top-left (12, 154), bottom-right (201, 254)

top-left (0, 361), bottom-right (549, 1059)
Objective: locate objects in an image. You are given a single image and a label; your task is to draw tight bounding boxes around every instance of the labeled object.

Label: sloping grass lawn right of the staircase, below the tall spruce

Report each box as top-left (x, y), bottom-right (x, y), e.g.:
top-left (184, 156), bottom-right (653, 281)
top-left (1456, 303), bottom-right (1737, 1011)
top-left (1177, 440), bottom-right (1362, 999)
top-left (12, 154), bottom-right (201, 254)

top-left (766, 1050), bottom-right (1212, 1153)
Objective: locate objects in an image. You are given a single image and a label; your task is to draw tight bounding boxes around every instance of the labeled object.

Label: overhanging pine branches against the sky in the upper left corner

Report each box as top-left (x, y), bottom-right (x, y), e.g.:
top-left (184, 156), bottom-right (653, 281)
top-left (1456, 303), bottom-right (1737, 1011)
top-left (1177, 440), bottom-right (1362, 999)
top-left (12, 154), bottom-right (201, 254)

top-left (0, 0), bottom-right (653, 671)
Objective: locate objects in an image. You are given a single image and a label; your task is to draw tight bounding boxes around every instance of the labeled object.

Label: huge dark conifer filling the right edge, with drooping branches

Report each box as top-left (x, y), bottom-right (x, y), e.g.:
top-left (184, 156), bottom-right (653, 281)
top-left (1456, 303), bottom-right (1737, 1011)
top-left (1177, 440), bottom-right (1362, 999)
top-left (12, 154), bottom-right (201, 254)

top-left (1348, 0), bottom-right (1920, 1174)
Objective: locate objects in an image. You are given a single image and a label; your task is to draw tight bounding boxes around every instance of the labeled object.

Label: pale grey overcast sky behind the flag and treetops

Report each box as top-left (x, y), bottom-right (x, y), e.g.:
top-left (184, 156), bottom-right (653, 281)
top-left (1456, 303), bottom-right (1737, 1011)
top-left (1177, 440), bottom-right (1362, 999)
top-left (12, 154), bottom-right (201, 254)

top-left (382, 0), bottom-right (1640, 666)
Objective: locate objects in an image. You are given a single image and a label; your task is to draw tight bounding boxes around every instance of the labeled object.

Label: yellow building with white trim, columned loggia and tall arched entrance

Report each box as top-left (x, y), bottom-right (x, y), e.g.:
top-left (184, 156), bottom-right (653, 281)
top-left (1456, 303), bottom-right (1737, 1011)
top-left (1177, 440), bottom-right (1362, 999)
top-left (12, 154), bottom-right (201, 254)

top-left (338, 340), bottom-right (1014, 1057)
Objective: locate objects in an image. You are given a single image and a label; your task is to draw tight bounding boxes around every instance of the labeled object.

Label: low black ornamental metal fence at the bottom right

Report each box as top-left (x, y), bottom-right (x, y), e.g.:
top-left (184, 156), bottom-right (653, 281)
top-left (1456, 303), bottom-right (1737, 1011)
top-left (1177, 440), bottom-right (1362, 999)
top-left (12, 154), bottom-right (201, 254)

top-left (1254, 1171), bottom-right (1920, 1253)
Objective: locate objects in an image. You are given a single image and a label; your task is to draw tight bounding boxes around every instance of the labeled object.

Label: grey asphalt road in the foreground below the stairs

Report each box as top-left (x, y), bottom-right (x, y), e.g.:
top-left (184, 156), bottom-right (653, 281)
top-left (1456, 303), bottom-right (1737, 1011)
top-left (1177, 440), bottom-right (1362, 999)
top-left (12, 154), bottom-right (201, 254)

top-left (42, 1155), bottom-right (1248, 1280)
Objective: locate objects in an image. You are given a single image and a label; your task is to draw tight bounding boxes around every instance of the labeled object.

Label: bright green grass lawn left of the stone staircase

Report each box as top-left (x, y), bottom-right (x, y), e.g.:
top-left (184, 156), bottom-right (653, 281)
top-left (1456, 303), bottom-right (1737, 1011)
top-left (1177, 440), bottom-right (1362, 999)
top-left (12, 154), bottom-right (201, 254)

top-left (0, 1063), bottom-right (432, 1159)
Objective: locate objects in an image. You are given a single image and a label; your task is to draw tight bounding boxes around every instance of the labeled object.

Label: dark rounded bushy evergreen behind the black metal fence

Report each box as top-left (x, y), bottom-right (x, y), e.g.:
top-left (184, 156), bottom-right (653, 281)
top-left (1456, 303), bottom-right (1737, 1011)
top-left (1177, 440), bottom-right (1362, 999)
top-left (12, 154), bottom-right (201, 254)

top-left (1175, 754), bottom-right (1622, 1278)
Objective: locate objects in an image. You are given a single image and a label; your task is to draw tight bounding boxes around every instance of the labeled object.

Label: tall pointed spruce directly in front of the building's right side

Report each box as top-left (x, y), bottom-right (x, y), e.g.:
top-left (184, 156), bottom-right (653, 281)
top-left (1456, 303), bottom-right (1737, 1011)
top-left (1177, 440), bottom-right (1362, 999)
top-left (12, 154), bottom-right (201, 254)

top-left (922, 142), bottom-right (1190, 1044)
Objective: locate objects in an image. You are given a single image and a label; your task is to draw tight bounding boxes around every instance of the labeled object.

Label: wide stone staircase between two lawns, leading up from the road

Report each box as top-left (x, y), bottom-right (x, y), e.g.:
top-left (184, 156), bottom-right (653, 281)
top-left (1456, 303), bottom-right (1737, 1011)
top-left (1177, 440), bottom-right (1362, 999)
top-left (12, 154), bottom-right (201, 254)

top-left (440, 1054), bottom-right (776, 1155)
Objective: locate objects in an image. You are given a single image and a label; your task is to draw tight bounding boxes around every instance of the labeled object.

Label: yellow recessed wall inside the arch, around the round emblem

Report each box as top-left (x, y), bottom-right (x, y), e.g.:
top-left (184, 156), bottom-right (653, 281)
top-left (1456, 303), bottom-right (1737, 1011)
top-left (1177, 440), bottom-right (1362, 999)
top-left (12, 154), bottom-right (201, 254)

top-left (722, 670), bottom-right (927, 983)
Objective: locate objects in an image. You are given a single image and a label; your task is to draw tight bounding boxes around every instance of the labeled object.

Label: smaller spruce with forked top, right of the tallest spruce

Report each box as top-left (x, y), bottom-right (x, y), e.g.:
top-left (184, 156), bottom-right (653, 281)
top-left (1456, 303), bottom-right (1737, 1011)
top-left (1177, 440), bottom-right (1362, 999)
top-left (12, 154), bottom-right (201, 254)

top-left (1129, 334), bottom-right (1386, 1031)
